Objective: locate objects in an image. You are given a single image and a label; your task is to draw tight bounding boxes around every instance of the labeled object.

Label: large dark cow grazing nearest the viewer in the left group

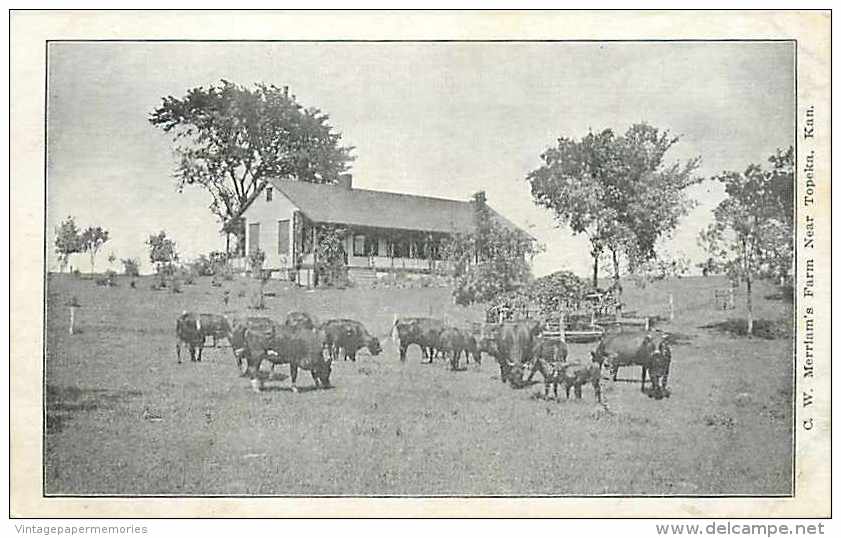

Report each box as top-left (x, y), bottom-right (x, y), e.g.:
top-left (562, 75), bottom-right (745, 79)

top-left (245, 325), bottom-right (333, 392)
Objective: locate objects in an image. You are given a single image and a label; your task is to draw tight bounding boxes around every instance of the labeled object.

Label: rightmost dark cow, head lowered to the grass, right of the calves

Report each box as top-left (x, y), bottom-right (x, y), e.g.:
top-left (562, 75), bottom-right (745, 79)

top-left (591, 333), bottom-right (672, 400)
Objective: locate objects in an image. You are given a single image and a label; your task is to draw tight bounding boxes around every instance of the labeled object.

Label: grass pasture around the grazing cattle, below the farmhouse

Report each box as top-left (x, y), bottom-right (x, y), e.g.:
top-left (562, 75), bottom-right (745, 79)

top-left (44, 275), bottom-right (792, 495)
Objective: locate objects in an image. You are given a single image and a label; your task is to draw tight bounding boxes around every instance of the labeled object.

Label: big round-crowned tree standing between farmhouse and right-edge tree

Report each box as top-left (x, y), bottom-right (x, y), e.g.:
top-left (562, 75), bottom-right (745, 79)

top-left (526, 123), bottom-right (700, 286)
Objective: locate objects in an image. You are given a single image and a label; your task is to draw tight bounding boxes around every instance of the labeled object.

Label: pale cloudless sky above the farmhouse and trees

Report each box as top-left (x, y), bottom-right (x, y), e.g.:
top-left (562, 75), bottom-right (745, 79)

top-left (47, 42), bottom-right (795, 276)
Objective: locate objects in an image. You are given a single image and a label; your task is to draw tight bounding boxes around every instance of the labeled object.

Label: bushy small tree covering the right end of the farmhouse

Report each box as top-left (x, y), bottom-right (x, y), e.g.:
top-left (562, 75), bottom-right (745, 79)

top-left (444, 192), bottom-right (538, 305)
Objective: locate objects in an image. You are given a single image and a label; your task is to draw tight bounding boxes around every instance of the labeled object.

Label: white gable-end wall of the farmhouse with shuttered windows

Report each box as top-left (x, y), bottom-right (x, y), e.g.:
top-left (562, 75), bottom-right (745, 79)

top-left (243, 188), bottom-right (298, 269)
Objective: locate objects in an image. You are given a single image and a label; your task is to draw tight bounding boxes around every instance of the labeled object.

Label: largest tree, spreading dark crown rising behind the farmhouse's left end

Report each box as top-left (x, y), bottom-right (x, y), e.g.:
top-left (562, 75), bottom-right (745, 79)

top-left (149, 80), bottom-right (353, 251)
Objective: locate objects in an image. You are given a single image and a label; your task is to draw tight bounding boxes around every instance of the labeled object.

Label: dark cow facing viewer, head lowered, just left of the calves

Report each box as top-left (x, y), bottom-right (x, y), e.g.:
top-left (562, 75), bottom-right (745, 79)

top-left (480, 320), bottom-right (542, 387)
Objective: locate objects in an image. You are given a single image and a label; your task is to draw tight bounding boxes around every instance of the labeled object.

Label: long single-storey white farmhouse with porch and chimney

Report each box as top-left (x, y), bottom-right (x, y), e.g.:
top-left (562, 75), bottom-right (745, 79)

top-left (230, 174), bottom-right (528, 286)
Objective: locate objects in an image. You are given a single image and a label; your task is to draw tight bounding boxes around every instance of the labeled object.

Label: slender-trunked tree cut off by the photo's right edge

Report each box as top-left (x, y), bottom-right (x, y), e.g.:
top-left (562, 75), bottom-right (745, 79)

top-left (699, 148), bottom-right (794, 335)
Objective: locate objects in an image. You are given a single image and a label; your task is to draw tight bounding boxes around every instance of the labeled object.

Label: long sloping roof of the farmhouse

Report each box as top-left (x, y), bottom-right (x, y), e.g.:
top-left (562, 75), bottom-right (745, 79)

top-left (258, 179), bottom-right (531, 237)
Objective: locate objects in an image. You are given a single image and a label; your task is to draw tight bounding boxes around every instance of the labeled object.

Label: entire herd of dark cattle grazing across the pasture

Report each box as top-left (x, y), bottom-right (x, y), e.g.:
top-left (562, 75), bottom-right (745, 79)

top-left (175, 312), bottom-right (671, 402)
